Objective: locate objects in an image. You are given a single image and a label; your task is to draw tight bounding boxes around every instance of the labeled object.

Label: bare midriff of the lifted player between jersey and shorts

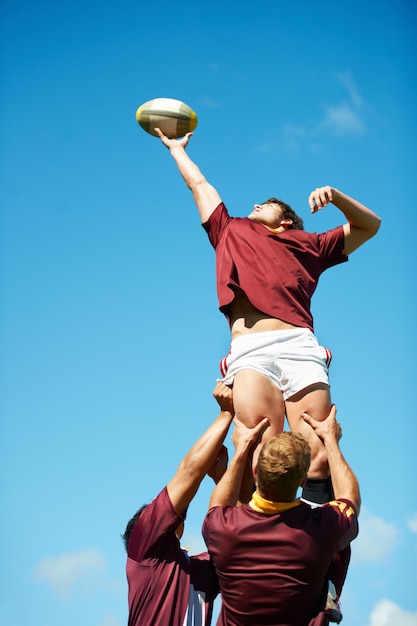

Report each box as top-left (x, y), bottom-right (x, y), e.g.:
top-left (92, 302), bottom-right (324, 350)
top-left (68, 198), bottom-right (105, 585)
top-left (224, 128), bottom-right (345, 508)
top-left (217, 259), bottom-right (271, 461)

top-left (229, 292), bottom-right (298, 339)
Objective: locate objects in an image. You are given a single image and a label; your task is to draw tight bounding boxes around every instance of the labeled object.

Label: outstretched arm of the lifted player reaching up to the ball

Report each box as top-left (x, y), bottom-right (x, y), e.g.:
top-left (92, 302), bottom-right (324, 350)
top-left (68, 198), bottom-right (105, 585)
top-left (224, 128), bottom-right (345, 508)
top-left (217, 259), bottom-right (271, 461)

top-left (155, 128), bottom-right (221, 223)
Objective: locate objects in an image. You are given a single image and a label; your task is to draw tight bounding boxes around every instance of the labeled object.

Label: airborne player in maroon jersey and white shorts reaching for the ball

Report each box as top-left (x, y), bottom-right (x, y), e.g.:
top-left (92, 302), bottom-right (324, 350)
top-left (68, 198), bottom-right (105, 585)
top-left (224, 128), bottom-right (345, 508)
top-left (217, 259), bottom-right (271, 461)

top-left (155, 129), bottom-right (380, 503)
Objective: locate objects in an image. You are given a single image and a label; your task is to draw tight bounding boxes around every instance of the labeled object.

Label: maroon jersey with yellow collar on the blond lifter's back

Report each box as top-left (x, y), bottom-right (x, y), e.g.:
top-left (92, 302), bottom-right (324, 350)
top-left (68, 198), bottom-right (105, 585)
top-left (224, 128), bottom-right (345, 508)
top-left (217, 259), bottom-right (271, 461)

top-left (203, 500), bottom-right (358, 626)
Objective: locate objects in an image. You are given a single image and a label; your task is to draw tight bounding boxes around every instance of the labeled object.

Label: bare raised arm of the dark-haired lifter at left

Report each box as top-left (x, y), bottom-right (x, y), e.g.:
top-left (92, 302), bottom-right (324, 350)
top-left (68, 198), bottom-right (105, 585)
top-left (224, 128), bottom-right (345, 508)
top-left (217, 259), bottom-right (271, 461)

top-left (167, 382), bottom-right (234, 515)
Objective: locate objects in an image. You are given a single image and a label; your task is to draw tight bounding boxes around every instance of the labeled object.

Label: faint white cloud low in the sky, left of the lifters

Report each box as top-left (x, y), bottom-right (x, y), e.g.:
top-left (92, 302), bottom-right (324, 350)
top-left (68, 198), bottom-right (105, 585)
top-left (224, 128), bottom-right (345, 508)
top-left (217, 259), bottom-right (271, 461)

top-left (35, 548), bottom-right (106, 599)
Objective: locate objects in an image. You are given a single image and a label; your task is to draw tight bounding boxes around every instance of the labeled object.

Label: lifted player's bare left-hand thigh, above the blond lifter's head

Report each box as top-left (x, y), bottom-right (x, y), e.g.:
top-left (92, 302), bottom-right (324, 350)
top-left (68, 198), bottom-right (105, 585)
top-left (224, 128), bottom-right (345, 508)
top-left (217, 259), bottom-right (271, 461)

top-left (233, 369), bottom-right (285, 436)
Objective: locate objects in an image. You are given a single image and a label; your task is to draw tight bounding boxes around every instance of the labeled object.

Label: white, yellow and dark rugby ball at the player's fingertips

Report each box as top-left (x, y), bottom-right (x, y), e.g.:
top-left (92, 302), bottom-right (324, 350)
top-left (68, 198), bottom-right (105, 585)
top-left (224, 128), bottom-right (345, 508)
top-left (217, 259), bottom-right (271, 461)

top-left (136, 98), bottom-right (198, 139)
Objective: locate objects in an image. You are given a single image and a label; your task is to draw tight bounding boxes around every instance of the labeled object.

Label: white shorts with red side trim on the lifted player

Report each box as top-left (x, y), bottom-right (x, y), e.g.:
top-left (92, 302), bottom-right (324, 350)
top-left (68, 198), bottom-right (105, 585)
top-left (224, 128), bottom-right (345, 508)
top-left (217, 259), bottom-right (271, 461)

top-left (220, 328), bottom-right (332, 400)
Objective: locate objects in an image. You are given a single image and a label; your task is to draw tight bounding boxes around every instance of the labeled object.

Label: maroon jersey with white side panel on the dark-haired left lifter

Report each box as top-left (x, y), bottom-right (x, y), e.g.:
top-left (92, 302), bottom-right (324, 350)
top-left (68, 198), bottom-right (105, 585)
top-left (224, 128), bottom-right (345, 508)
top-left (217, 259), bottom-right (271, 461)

top-left (126, 487), bottom-right (218, 626)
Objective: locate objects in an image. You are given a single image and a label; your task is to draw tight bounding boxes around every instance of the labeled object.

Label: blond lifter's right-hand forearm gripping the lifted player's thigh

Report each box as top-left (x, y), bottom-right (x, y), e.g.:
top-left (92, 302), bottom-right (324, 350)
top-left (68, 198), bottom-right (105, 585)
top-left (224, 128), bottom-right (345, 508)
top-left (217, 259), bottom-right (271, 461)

top-left (302, 405), bottom-right (361, 514)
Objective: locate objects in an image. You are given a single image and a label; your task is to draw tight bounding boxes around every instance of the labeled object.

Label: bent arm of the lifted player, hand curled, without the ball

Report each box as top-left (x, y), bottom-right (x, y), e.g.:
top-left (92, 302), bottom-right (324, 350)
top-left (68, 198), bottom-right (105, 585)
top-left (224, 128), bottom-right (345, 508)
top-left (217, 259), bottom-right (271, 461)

top-left (308, 186), bottom-right (381, 255)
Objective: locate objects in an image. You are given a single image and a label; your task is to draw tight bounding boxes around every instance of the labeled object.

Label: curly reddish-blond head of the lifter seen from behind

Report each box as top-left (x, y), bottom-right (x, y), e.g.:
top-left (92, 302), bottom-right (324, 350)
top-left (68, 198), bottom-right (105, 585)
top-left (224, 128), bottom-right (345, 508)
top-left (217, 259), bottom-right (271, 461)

top-left (255, 432), bottom-right (311, 502)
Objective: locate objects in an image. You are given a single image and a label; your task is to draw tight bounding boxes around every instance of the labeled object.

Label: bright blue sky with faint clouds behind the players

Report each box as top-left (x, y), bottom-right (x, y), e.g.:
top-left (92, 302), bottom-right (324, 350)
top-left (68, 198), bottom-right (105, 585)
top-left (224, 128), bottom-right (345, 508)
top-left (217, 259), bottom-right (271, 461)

top-left (0, 0), bottom-right (417, 626)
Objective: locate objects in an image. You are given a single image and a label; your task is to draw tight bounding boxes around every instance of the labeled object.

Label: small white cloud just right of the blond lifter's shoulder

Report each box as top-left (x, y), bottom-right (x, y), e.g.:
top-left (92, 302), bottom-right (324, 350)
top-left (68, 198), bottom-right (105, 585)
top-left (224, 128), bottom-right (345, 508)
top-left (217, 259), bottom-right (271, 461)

top-left (352, 516), bottom-right (398, 565)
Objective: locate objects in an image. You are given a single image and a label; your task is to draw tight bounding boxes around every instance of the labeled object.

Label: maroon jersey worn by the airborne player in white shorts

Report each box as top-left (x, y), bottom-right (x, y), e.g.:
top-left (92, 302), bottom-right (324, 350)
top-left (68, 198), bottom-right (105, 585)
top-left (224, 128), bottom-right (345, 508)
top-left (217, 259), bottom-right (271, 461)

top-left (203, 203), bottom-right (348, 332)
